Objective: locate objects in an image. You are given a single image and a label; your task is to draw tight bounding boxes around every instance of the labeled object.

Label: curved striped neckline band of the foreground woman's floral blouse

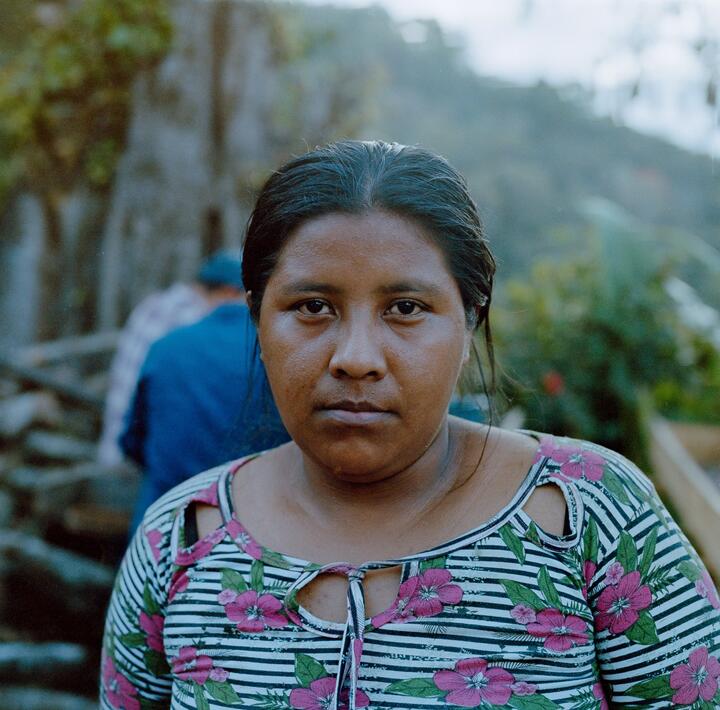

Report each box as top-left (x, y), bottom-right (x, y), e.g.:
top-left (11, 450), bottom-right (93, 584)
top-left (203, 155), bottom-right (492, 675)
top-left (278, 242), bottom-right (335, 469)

top-left (218, 429), bottom-right (549, 571)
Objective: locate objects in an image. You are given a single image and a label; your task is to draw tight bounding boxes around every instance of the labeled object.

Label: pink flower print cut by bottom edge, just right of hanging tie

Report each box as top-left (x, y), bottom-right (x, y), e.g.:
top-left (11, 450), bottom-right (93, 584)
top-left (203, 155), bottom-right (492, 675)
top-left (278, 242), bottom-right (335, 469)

top-left (433, 658), bottom-right (515, 708)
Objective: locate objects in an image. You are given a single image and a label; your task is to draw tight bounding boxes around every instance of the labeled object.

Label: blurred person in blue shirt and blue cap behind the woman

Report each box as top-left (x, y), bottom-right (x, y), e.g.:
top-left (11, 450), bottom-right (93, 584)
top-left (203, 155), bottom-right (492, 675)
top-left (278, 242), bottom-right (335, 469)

top-left (120, 254), bottom-right (289, 533)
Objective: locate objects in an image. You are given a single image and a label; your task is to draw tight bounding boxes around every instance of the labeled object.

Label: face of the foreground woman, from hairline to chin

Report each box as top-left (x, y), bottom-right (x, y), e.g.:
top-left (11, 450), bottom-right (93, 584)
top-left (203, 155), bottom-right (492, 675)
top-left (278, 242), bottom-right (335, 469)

top-left (258, 211), bottom-right (471, 482)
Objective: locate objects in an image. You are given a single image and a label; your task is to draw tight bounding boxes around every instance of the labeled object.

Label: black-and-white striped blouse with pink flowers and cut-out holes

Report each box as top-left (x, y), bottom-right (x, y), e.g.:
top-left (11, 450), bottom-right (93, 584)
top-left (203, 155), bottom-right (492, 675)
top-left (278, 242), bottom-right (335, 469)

top-left (101, 437), bottom-right (720, 710)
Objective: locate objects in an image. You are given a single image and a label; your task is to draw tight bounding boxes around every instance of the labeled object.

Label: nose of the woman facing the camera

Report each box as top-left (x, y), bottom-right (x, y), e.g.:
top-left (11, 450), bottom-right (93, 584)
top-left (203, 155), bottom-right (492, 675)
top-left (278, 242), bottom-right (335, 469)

top-left (330, 316), bottom-right (387, 380)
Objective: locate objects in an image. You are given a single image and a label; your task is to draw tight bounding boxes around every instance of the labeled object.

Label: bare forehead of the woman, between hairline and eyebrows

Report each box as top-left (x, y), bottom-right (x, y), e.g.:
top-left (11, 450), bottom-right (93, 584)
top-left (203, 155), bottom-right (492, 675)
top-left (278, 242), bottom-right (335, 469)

top-left (273, 210), bottom-right (455, 286)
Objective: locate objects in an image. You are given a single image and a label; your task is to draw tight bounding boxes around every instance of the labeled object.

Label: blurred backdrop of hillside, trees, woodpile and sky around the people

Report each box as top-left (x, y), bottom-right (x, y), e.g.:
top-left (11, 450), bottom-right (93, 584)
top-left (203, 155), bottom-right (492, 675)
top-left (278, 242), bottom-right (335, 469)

top-left (0, 0), bottom-right (720, 710)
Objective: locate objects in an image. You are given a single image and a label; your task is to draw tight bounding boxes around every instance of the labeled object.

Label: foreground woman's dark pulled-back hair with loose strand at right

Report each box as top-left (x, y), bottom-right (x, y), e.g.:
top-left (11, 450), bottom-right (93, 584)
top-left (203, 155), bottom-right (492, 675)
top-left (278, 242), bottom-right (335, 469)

top-left (242, 141), bottom-right (495, 406)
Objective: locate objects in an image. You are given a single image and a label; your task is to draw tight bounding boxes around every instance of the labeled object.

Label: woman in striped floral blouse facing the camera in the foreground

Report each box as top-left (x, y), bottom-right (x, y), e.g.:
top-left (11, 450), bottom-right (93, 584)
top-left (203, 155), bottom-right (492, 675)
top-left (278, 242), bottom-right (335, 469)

top-left (102, 142), bottom-right (720, 709)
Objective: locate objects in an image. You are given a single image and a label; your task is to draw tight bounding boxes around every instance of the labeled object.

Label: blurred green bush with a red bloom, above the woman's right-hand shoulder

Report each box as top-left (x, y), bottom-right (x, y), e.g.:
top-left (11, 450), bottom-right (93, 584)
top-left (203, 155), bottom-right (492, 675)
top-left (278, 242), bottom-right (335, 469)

top-left (496, 202), bottom-right (717, 467)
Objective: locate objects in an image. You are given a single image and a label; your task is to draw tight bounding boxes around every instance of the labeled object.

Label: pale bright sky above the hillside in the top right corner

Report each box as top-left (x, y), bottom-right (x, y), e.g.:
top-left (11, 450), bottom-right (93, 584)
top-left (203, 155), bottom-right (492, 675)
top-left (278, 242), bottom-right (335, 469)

top-left (298, 0), bottom-right (720, 156)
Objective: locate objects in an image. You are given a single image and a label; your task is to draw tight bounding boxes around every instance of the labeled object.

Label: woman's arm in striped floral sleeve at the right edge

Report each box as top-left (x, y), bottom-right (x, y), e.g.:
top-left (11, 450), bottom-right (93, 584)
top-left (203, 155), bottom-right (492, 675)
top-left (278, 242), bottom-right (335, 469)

top-left (589, 471), bottom-right (720, 710)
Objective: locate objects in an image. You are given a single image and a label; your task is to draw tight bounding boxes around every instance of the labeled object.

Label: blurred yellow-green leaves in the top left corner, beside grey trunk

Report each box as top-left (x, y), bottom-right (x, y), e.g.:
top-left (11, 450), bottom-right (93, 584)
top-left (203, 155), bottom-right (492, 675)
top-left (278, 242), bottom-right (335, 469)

top-left (0, 0), bottom-right (171, 206)
